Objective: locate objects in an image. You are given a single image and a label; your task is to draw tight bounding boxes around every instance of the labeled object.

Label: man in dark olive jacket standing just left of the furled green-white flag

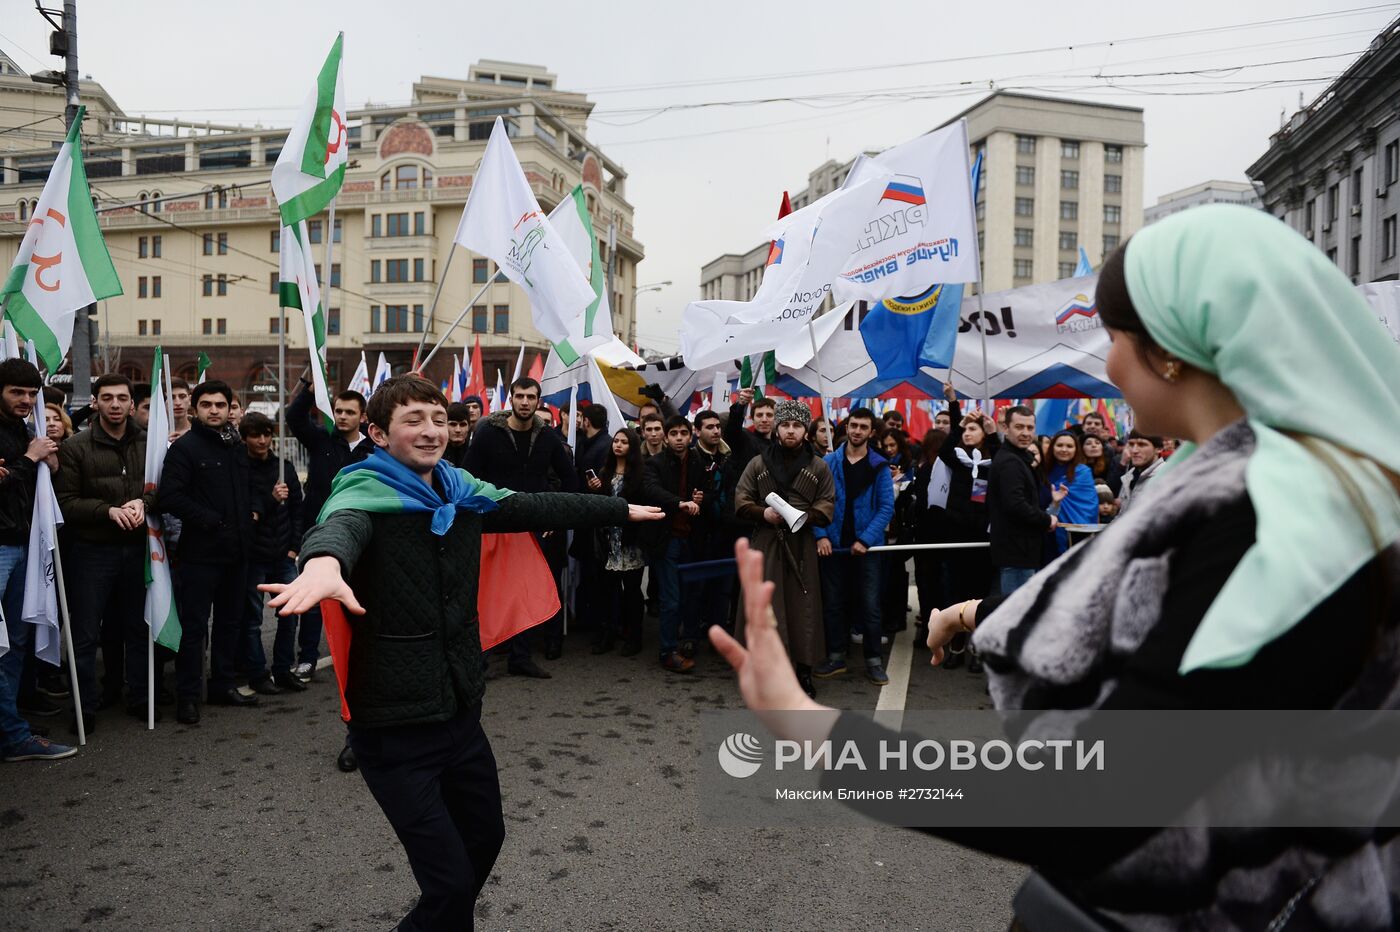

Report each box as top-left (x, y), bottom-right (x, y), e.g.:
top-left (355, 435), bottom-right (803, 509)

top-left (53, 374), bottom-right (160, 732)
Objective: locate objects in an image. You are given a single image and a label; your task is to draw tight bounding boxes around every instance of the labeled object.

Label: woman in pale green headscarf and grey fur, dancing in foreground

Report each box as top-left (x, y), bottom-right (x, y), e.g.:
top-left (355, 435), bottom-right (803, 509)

top-left (711, 206), bottom-right (1400, 928)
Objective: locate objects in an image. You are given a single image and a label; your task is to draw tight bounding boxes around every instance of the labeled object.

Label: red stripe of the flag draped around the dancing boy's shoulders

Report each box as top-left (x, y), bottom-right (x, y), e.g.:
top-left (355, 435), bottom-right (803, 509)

top-left (321, 528), bottom-right (559, 722)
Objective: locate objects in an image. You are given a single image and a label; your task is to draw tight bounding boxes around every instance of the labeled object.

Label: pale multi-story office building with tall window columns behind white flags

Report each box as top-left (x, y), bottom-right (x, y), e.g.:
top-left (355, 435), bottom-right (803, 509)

top-left (700, 91), bottom-right (1144, 301)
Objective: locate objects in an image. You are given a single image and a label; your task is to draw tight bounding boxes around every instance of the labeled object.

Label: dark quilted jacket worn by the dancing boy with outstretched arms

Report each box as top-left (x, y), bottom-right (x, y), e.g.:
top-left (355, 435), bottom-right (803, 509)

top-left (300, 481), bottom-right (627, 728)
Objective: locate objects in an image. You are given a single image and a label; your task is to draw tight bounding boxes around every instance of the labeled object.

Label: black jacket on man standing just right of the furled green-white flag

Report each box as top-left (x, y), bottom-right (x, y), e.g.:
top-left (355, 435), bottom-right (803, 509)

top-left (157, 420), bottom-right (262, 564)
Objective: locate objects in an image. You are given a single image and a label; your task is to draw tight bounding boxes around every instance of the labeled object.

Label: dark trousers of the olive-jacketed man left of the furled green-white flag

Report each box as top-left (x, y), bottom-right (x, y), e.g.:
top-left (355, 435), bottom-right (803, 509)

top-left (69, 540), bottom-right (148, 712)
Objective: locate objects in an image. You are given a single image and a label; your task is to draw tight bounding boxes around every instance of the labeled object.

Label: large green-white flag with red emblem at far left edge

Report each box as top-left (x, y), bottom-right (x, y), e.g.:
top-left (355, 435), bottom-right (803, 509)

top-left (0, 106), bottom-right (122, 372)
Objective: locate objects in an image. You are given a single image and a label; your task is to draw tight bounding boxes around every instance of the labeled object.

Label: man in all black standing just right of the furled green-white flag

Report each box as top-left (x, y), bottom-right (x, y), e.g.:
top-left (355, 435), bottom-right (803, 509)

top-left (157, 381), bottom-right (263, 725)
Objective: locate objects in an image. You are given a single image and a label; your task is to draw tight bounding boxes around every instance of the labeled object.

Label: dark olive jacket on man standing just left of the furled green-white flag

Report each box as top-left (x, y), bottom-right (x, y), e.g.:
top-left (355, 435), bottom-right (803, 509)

top-left (53, 417), bottom-right (155, 544)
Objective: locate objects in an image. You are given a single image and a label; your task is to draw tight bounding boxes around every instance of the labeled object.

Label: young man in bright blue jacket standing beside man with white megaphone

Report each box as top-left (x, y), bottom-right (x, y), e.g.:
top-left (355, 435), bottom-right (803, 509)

top-left (812, 407), bottom-right (895, 686)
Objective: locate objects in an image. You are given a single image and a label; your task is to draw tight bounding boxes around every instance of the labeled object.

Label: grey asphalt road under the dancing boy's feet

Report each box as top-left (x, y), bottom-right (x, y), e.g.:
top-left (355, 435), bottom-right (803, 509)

top-left (0, 590), bottom-right (1025, 931)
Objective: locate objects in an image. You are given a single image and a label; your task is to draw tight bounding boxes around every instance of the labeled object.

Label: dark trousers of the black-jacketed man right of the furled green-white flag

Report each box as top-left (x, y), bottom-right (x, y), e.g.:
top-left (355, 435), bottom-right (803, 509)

top-left (175, 561), bottom-right (248, 701)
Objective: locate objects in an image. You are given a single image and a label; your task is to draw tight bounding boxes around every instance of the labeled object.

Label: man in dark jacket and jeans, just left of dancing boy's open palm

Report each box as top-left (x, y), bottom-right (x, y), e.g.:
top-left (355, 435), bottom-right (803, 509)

top-left (238, 411), bottom-right (307, 696)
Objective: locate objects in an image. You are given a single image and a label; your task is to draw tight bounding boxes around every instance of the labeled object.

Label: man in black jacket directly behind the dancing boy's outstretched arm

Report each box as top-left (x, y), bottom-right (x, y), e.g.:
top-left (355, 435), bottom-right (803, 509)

top-left (465, 378), bottom-right (578, 679)
